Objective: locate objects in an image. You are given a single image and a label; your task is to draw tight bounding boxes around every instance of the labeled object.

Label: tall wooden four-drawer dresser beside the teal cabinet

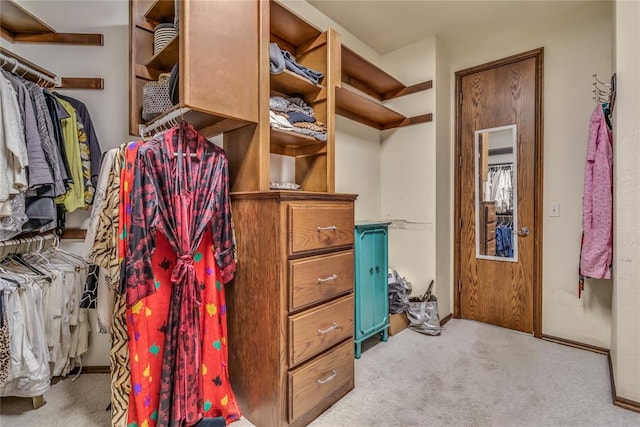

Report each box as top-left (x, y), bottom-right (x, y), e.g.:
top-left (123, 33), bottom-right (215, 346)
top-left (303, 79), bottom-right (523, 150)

top-left (226, 191), bottom-right (356, 426)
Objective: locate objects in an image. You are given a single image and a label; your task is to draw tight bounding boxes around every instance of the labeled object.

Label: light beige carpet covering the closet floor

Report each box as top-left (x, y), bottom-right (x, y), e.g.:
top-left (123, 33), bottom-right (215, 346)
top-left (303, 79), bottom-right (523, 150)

top-left (0, 320), bottom-right (640, 427)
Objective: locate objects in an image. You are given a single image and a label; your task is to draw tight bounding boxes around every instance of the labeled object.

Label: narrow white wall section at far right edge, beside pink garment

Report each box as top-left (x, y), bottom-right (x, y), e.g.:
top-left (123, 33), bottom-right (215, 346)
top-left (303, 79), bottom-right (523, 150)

top-left (611, 1), bottom-right (640, 402)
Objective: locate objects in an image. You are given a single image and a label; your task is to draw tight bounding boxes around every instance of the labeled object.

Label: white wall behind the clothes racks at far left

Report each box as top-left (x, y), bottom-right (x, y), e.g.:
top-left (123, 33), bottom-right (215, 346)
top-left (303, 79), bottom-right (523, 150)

top-left (0, 1), bottom-right (130, 366)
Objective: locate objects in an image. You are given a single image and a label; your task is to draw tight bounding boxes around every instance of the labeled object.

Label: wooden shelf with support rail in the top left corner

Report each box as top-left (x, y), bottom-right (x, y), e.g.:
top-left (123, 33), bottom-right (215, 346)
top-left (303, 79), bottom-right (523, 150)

top-left (0, 0), bottom-right (104, 46)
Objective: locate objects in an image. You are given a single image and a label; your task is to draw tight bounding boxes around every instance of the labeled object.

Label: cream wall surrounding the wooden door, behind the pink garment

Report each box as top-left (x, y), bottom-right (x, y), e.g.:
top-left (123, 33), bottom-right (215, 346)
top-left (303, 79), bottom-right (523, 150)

top-left (444, 2), bottom-right (616, 348)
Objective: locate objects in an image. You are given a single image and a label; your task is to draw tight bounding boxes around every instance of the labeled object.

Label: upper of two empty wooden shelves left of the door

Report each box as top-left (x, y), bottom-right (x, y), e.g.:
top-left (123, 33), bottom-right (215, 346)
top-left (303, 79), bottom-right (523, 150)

top-left (342, 45), bottom-right (406, 98)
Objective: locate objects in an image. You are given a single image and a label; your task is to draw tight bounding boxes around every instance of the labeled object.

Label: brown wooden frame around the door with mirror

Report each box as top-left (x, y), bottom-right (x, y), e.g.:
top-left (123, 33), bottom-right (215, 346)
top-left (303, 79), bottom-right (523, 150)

top-left (453, 47), bottom-right (544, 338)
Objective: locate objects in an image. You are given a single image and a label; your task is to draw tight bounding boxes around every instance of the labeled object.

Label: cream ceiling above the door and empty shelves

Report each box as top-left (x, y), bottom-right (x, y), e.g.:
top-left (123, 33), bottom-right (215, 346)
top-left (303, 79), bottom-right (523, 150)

top-left (307, 0), bottom-right (594, 54)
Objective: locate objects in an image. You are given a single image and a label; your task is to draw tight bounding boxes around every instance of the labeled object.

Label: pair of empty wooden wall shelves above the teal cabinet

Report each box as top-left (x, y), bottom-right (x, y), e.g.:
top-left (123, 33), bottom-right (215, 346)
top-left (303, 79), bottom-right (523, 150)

top-left (336, 46), bottom-right (433, 130)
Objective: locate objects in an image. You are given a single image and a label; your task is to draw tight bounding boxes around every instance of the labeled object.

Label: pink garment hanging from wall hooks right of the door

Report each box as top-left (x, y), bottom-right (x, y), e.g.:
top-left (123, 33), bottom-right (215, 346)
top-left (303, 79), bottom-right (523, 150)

top-left (580, 105), bottom-right (613, 279)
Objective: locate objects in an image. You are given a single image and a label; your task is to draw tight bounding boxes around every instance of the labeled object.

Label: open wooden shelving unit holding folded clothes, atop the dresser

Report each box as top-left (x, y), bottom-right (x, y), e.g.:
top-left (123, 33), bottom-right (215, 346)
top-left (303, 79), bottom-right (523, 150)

top-left (224, 1), bottom-right (340, 192)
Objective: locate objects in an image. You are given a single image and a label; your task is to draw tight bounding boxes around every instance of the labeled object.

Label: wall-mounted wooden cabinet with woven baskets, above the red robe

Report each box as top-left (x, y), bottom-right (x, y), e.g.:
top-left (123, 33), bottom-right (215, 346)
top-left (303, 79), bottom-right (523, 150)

top-left (129, 0), bottom-right (259, 136)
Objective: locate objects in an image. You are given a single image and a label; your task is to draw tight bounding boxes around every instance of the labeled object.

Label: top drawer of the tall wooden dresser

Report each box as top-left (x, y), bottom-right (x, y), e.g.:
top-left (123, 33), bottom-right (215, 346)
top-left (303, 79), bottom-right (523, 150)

top-left (288, 203), bottom-right (354, 255)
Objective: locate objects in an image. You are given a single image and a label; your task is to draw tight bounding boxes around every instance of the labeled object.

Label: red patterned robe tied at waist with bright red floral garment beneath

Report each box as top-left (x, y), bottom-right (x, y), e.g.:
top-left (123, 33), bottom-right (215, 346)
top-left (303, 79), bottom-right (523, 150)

top-left (125, 122), bottom-right (241, 426)
